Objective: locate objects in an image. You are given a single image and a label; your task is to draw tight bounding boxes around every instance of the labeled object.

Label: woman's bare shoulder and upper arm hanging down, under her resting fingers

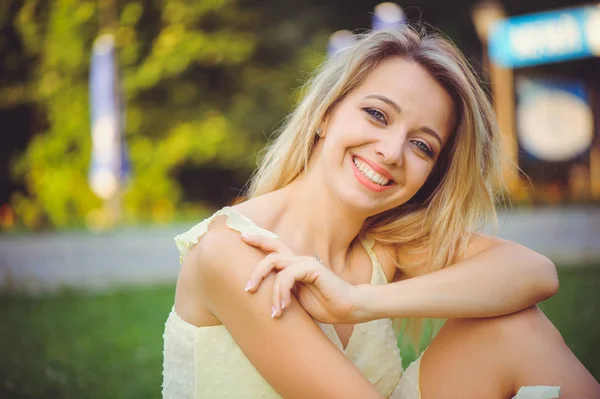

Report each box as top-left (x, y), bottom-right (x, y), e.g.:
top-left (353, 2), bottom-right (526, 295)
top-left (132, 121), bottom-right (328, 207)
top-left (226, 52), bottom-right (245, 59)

top-left (188, 223), bottom-right (380, 398)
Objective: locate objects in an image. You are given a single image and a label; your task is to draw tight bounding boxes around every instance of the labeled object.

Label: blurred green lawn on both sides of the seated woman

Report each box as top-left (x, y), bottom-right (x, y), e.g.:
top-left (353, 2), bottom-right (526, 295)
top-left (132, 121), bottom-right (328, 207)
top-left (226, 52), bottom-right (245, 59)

top-left (0, 265), bottom-right (600, 398)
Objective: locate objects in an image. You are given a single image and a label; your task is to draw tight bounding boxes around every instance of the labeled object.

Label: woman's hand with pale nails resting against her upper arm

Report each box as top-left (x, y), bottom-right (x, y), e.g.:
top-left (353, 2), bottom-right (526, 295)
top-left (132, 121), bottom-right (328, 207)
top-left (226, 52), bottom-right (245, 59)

top-left (242, 235), bottom-right (359, 324)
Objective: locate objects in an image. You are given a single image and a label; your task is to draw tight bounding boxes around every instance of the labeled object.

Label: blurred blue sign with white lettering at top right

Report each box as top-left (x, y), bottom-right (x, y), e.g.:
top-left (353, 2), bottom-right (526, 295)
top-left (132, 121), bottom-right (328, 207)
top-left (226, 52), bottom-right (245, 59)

top-left (488, 6), bottom-right (600, 68)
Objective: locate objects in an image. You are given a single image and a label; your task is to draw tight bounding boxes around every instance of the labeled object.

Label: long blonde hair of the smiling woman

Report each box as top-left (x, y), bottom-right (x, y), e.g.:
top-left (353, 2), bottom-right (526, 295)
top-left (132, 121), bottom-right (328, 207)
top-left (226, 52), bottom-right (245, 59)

top-left (248, 26), bottom-right (503, 344)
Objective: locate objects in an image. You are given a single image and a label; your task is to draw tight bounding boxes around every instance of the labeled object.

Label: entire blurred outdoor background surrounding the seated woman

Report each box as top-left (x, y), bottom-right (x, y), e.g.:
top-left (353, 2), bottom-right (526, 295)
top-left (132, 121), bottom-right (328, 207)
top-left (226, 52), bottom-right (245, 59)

top-left (0, 0), bottom-right (600, 398)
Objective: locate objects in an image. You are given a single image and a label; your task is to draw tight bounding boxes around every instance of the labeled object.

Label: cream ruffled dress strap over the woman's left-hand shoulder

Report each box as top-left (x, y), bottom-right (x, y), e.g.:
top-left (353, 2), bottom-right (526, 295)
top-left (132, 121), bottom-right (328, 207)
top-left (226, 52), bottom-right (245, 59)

top-left (174, 206), bottom-right (277, 262)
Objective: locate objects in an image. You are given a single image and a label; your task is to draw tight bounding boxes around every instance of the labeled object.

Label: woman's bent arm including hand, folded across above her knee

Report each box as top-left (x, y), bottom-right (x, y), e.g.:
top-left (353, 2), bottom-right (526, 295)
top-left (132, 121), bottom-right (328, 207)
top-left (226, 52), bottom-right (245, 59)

top-left (244, 236), bottom-right (558, 323)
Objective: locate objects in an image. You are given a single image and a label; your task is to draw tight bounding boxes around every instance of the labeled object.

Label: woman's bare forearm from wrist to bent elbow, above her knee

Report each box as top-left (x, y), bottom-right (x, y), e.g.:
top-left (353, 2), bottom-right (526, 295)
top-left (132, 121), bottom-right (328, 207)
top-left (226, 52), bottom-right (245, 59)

top-left (356, 243), bottom-right (558, 320)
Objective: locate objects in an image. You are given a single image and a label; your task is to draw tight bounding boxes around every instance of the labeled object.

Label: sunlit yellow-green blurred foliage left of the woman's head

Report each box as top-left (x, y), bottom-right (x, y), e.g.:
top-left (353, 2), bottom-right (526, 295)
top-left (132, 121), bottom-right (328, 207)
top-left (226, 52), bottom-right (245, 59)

top-left (0, 0), bottom-right (325, 228)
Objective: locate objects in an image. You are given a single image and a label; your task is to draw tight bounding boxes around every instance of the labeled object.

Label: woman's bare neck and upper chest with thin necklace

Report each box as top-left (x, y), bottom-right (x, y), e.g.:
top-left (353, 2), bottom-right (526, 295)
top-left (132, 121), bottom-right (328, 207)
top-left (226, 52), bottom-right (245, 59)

top-left (278, 167), bottom-right (366, 271)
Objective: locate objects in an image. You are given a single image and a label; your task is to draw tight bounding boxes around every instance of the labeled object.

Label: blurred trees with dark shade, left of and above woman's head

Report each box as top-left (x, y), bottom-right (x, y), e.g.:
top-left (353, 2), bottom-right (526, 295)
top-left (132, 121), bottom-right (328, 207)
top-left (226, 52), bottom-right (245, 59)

top-left (0, 0), bottom-right (583, 229)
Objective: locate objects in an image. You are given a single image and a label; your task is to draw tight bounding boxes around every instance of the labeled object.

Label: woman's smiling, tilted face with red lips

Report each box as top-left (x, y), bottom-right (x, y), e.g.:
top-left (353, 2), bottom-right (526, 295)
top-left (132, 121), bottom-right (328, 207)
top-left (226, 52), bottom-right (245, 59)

top-left (317, 58), bottom-right (454, 216)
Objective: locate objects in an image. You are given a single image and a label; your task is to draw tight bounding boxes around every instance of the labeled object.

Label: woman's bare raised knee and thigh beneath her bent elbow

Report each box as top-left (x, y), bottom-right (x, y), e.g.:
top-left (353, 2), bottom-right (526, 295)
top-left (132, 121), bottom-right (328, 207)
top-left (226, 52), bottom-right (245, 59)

top-left (419, 306), bottom-right (600, 399)
